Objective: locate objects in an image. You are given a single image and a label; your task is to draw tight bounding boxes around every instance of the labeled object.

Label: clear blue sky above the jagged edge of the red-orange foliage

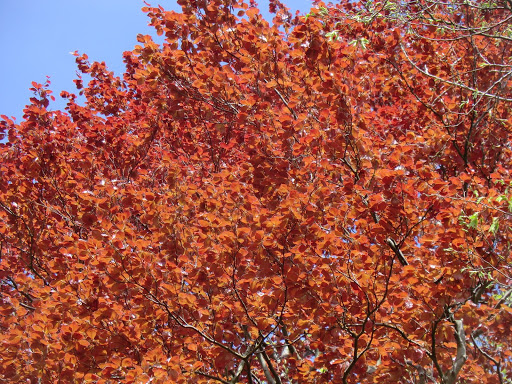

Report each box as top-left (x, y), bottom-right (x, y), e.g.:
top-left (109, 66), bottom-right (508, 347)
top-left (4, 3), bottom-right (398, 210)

top-left (0, 0), bottom-right (312, 122)
